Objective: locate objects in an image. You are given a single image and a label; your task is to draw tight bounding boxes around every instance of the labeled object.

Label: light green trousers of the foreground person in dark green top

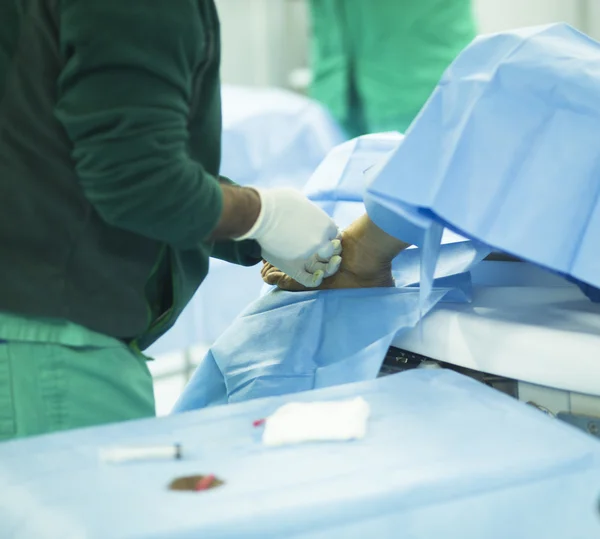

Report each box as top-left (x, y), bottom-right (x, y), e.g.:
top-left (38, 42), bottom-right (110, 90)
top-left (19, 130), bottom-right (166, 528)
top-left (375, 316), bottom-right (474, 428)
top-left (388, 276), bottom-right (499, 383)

top-left (0, 313), bottom-right (155, 441)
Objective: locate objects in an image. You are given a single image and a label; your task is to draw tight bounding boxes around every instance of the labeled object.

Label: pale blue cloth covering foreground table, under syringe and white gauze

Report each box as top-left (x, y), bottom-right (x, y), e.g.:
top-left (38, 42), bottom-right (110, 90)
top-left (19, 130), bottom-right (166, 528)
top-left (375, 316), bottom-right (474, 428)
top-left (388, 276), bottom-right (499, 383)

top-left (0, 370), bottom-right (600, 539)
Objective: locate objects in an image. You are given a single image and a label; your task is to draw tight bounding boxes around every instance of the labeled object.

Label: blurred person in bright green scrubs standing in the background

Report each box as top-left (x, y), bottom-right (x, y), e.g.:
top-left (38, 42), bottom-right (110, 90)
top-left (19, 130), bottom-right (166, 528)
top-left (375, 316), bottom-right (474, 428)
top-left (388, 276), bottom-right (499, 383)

top-left (310, 0), bottom-right (476, 137)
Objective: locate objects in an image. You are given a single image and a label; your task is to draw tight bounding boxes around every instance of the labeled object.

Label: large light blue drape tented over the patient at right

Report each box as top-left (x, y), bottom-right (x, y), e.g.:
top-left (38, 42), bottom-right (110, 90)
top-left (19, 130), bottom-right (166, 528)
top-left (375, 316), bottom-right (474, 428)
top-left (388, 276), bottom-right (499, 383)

top-left (365, 24), bottom-right (600, 287)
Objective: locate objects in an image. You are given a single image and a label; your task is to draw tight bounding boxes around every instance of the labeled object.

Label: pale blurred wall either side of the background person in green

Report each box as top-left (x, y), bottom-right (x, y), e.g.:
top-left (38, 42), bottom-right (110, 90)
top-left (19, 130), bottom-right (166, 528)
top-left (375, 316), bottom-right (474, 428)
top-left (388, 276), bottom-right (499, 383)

top-left (216, 0), bottom-right (600, 91)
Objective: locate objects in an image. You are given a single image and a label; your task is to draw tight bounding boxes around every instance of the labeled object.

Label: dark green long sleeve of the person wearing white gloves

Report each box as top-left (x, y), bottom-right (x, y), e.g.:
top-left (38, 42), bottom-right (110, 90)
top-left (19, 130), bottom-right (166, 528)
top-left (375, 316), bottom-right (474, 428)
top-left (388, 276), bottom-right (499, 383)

top-left (56, 0), bottom-right (223, 248)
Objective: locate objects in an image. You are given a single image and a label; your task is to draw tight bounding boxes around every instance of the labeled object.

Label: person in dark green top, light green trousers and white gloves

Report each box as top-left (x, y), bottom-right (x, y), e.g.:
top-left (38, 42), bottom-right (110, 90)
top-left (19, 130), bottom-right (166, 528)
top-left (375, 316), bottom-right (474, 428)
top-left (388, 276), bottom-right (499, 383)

top-left (0, 0), bottom-right (341, 440)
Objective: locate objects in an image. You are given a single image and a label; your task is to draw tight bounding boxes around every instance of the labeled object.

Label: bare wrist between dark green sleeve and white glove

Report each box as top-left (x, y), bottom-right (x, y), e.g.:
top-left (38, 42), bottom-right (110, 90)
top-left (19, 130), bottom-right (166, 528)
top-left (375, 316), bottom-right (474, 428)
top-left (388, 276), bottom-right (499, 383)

top-left (210, 182), bottom-right (260, 241)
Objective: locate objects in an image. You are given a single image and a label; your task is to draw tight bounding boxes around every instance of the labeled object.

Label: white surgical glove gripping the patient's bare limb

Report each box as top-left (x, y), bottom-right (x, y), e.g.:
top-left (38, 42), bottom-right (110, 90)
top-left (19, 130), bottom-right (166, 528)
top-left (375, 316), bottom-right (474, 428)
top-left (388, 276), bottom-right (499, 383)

top-left (236, 188), bottom-right (342, 288)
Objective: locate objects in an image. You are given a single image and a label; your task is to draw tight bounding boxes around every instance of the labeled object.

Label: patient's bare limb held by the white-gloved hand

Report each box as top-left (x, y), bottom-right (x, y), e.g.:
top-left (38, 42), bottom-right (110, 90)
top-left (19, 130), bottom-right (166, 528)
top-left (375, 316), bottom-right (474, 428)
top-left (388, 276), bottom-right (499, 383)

top-left (261, 215), bottom-right (408, 292)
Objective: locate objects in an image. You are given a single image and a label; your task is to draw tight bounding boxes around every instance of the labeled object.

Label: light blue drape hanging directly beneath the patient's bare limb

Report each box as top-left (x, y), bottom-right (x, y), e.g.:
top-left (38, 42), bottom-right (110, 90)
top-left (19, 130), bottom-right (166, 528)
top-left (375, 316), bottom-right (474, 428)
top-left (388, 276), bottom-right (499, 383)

top-left (174, 288), bottom-right (447, 412)
